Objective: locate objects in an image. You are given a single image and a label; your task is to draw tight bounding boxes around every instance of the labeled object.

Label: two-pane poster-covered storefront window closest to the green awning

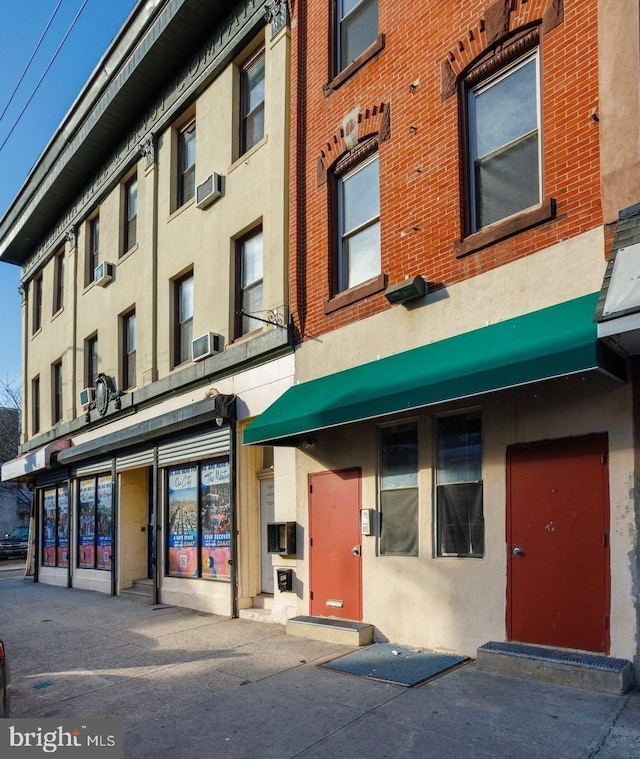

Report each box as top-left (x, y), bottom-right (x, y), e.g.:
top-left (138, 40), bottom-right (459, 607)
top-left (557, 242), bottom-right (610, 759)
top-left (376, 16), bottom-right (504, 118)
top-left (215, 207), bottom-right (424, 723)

top-left (167, 459), bottom-right (231, 581)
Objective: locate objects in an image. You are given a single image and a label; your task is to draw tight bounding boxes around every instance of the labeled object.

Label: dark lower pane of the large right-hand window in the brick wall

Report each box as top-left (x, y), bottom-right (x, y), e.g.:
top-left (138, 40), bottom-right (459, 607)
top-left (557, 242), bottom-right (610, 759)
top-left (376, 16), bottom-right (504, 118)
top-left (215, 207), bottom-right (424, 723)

top-left (475, 132), bottom-right (540, 229)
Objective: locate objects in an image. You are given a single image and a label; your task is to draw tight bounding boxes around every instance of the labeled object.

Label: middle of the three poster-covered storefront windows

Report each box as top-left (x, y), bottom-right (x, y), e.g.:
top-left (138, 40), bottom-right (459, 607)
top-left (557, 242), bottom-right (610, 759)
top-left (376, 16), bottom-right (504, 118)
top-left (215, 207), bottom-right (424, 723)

top-left (78, 474), bottom-right (113, 570)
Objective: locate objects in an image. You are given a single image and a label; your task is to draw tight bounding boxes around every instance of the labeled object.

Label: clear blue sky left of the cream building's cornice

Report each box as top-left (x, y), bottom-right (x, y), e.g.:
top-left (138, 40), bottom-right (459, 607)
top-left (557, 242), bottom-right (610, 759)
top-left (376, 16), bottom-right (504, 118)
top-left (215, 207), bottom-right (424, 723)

top-left (0, 0), bottom-right (137, 382)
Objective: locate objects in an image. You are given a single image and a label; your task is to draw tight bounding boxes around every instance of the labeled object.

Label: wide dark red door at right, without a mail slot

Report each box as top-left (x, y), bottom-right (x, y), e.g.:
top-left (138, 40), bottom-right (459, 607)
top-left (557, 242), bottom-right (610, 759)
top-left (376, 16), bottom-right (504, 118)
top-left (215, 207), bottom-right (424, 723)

top-left (507, 435), bottom-right (609, 653)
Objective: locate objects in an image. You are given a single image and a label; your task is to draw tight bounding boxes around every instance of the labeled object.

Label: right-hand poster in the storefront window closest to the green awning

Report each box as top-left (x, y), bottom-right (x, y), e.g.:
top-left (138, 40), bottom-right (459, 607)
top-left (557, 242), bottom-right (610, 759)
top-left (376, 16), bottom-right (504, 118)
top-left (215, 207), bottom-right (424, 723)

top-left (200, 461), bottom-right (231, 580)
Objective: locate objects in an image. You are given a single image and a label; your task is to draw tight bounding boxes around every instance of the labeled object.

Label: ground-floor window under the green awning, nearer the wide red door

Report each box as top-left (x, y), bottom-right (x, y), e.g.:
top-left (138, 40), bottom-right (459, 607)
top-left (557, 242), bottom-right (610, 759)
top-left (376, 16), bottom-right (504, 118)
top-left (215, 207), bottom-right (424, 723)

top-left (435, 411), bottom-right (484, 558)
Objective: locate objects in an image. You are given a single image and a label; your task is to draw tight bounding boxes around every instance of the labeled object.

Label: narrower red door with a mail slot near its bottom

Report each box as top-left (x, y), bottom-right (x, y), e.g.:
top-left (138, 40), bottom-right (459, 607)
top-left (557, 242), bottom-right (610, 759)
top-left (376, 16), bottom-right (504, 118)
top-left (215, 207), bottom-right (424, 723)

top-left (309, 469), bottom-right (362, 621)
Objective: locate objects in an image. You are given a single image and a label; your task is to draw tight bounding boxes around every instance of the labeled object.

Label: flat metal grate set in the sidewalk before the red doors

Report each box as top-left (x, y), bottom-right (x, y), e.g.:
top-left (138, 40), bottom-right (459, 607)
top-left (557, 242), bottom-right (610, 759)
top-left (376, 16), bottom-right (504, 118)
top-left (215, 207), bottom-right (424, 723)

top-left (322, 643), bottom-right (467, 686)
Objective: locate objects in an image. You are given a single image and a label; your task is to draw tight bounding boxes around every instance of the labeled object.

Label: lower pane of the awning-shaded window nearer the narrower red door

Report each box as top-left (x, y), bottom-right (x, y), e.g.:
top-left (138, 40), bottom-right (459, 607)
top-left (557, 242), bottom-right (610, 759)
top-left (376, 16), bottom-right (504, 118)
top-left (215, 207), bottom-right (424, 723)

top-left (380, 488), bottom-right (418, 556)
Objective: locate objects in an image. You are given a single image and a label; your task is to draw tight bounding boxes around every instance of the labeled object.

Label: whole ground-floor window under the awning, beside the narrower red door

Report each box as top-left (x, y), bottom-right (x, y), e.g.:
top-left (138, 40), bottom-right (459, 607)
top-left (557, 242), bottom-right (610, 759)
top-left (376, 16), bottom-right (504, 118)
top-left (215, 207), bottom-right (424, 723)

top-left (378, 422), bottom-right (418, 556)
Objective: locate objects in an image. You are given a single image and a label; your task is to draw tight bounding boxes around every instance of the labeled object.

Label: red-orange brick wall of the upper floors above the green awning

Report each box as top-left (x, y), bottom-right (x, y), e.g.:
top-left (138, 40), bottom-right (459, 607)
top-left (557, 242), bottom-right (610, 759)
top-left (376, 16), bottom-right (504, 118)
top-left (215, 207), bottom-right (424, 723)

top-left (290, 0), bottom-right (602, 338)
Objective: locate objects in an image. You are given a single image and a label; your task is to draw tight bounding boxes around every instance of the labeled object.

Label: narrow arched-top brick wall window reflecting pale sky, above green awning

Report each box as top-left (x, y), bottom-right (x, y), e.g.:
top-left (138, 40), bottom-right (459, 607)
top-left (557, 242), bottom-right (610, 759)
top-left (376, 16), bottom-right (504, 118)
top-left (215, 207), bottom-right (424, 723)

top-left (336, 153), bottom-right (381, 292)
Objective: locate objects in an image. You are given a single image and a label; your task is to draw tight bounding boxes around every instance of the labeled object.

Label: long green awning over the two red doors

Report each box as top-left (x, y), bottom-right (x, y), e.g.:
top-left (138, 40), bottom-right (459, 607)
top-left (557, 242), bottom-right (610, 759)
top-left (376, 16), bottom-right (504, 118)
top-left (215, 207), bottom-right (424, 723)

top-left (244, 293), bottom-right (625, 445)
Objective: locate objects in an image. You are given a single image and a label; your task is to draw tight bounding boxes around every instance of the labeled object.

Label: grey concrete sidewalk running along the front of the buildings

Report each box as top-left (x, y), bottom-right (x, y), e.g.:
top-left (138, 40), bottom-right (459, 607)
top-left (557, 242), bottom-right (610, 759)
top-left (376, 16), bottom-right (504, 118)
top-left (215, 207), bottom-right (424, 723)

top-left (0, 576), bottom-right (640, 759)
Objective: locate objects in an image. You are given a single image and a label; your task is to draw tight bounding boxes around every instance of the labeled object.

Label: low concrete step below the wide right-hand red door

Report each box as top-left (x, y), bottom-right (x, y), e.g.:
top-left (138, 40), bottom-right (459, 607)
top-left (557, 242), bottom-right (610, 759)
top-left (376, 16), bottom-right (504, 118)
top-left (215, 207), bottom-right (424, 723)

top-left (476, 641), bottom-right (634, 695)
